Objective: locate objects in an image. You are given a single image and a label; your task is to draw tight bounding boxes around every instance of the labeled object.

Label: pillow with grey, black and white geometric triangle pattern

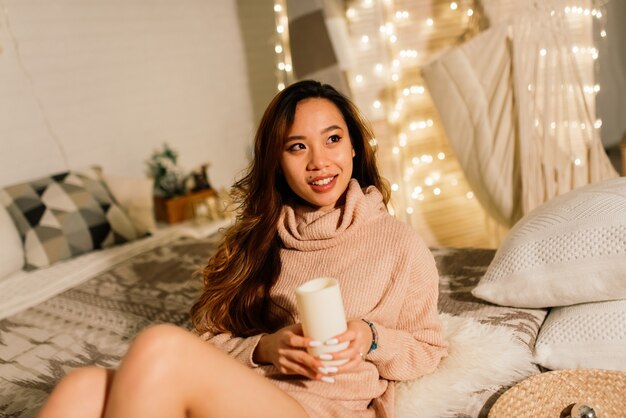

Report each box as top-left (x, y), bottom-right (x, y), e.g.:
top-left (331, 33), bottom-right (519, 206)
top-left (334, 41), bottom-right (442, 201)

top-left (0, 167), bottom-right (137, 270)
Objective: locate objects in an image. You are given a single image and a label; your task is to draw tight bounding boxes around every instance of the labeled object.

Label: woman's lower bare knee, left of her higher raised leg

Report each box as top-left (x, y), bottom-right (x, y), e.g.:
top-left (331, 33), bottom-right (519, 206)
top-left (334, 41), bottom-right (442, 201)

top-left (38, 367), bottom-right (115, 418)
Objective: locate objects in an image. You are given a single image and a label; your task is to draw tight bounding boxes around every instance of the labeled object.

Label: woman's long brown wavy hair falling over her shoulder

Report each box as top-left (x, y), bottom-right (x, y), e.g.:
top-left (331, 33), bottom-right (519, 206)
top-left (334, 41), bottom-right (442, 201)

top-left (191, 80), bottom-right (390, 337)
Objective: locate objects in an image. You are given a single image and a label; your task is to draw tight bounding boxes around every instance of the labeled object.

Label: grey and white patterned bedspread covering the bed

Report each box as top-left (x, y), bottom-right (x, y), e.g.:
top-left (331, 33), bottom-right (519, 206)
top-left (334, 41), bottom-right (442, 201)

top-left (0, 234), bottom-right (545, 417)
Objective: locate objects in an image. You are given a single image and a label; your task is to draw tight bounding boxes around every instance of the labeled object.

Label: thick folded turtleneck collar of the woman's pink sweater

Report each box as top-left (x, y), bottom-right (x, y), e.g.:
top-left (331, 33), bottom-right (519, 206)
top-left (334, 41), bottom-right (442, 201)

top-left (278, 179), bottom-right (387, 251)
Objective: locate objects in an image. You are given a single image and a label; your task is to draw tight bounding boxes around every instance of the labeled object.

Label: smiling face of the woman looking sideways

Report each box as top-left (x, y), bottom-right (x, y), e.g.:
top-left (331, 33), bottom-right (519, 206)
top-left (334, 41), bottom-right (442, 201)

top-left (280, 98), bottom-right (355, 210)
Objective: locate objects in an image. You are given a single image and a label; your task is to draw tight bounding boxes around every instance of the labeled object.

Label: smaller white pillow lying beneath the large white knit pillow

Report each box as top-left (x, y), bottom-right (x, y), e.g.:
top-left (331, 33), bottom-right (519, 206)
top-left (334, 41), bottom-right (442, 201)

top-left (534, 300), bottom-right (626, 371)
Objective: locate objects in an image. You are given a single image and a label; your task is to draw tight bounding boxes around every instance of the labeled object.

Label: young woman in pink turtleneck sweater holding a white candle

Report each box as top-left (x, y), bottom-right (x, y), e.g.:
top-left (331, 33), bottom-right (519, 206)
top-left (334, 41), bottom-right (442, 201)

top-left (40, 81), bottom-right (447, 418)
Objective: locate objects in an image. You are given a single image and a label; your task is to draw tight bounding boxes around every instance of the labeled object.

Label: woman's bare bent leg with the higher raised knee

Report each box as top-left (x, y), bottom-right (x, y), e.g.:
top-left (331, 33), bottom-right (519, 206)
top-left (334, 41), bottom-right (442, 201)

top-left (42, 325), bottom-right (307, 418)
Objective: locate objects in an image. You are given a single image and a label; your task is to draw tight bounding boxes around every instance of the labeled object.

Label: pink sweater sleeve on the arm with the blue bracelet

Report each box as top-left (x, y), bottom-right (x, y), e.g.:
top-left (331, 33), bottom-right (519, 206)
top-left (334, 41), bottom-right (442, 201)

top-left (367, 233), bottom-right (448, 380)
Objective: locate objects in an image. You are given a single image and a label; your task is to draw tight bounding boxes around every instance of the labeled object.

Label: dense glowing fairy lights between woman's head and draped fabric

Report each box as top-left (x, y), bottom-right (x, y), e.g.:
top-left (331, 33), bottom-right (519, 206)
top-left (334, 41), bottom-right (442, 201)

top-left (346, 0), bottom-right (474, 220)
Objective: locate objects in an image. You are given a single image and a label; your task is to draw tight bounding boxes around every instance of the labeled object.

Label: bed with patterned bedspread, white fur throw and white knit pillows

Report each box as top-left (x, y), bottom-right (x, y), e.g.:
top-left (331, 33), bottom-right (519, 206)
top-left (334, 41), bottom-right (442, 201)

top-left (0, 171), bottom-right (626, 418)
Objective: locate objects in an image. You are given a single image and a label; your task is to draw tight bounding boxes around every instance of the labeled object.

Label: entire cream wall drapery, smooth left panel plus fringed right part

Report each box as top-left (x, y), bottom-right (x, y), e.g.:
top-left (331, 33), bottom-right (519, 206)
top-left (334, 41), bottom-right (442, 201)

top-left (422, 0), bottom-right (618, 226)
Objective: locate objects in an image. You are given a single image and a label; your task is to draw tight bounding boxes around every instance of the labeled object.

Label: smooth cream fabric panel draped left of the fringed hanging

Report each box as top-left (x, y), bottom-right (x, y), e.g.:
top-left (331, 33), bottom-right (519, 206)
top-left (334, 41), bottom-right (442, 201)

top-left (422, 27), bottom-right (520, 225)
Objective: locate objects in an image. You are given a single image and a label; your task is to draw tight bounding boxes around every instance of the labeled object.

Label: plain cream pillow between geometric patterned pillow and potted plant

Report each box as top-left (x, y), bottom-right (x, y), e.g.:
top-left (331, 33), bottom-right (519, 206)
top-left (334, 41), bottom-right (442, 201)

top-left (102, 174), bottom-right (157, 235)
